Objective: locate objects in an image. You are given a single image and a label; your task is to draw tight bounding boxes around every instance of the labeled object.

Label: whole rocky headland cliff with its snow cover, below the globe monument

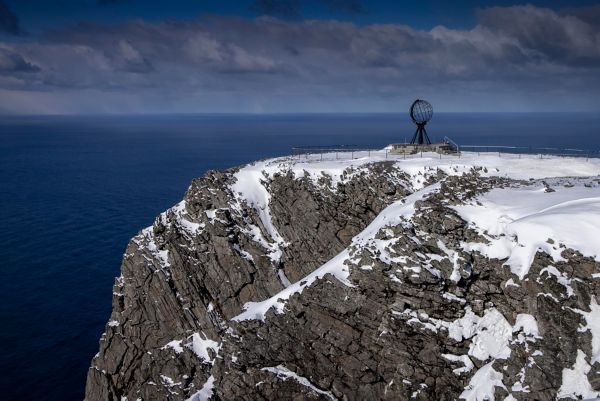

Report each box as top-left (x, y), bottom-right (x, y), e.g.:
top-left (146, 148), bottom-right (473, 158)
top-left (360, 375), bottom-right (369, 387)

top-left (86, 153), bottom-right (600, 401)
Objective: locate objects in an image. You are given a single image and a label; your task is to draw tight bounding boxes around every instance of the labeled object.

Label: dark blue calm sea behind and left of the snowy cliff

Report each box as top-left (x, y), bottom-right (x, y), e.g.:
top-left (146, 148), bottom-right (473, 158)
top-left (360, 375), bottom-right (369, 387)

top-left (0, 114), bottom-right (600, 401)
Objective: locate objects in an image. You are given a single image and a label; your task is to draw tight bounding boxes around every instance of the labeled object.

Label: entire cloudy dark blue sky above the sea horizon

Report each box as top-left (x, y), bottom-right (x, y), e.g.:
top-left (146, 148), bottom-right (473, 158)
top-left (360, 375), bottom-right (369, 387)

top-left (0, 0), bottom-right (600, 114)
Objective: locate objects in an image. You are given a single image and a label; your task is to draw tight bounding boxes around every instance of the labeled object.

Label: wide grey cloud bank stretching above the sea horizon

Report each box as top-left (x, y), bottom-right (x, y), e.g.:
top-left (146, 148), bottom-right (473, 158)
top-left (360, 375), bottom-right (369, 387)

top-left (0, 6), bottom-right (600, 112)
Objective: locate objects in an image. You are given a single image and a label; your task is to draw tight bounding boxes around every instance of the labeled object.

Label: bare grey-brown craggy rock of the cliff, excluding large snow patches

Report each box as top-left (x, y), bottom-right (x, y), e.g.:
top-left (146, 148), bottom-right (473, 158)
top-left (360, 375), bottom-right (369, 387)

top-left (86, 162), bottom-right (600, 401)
